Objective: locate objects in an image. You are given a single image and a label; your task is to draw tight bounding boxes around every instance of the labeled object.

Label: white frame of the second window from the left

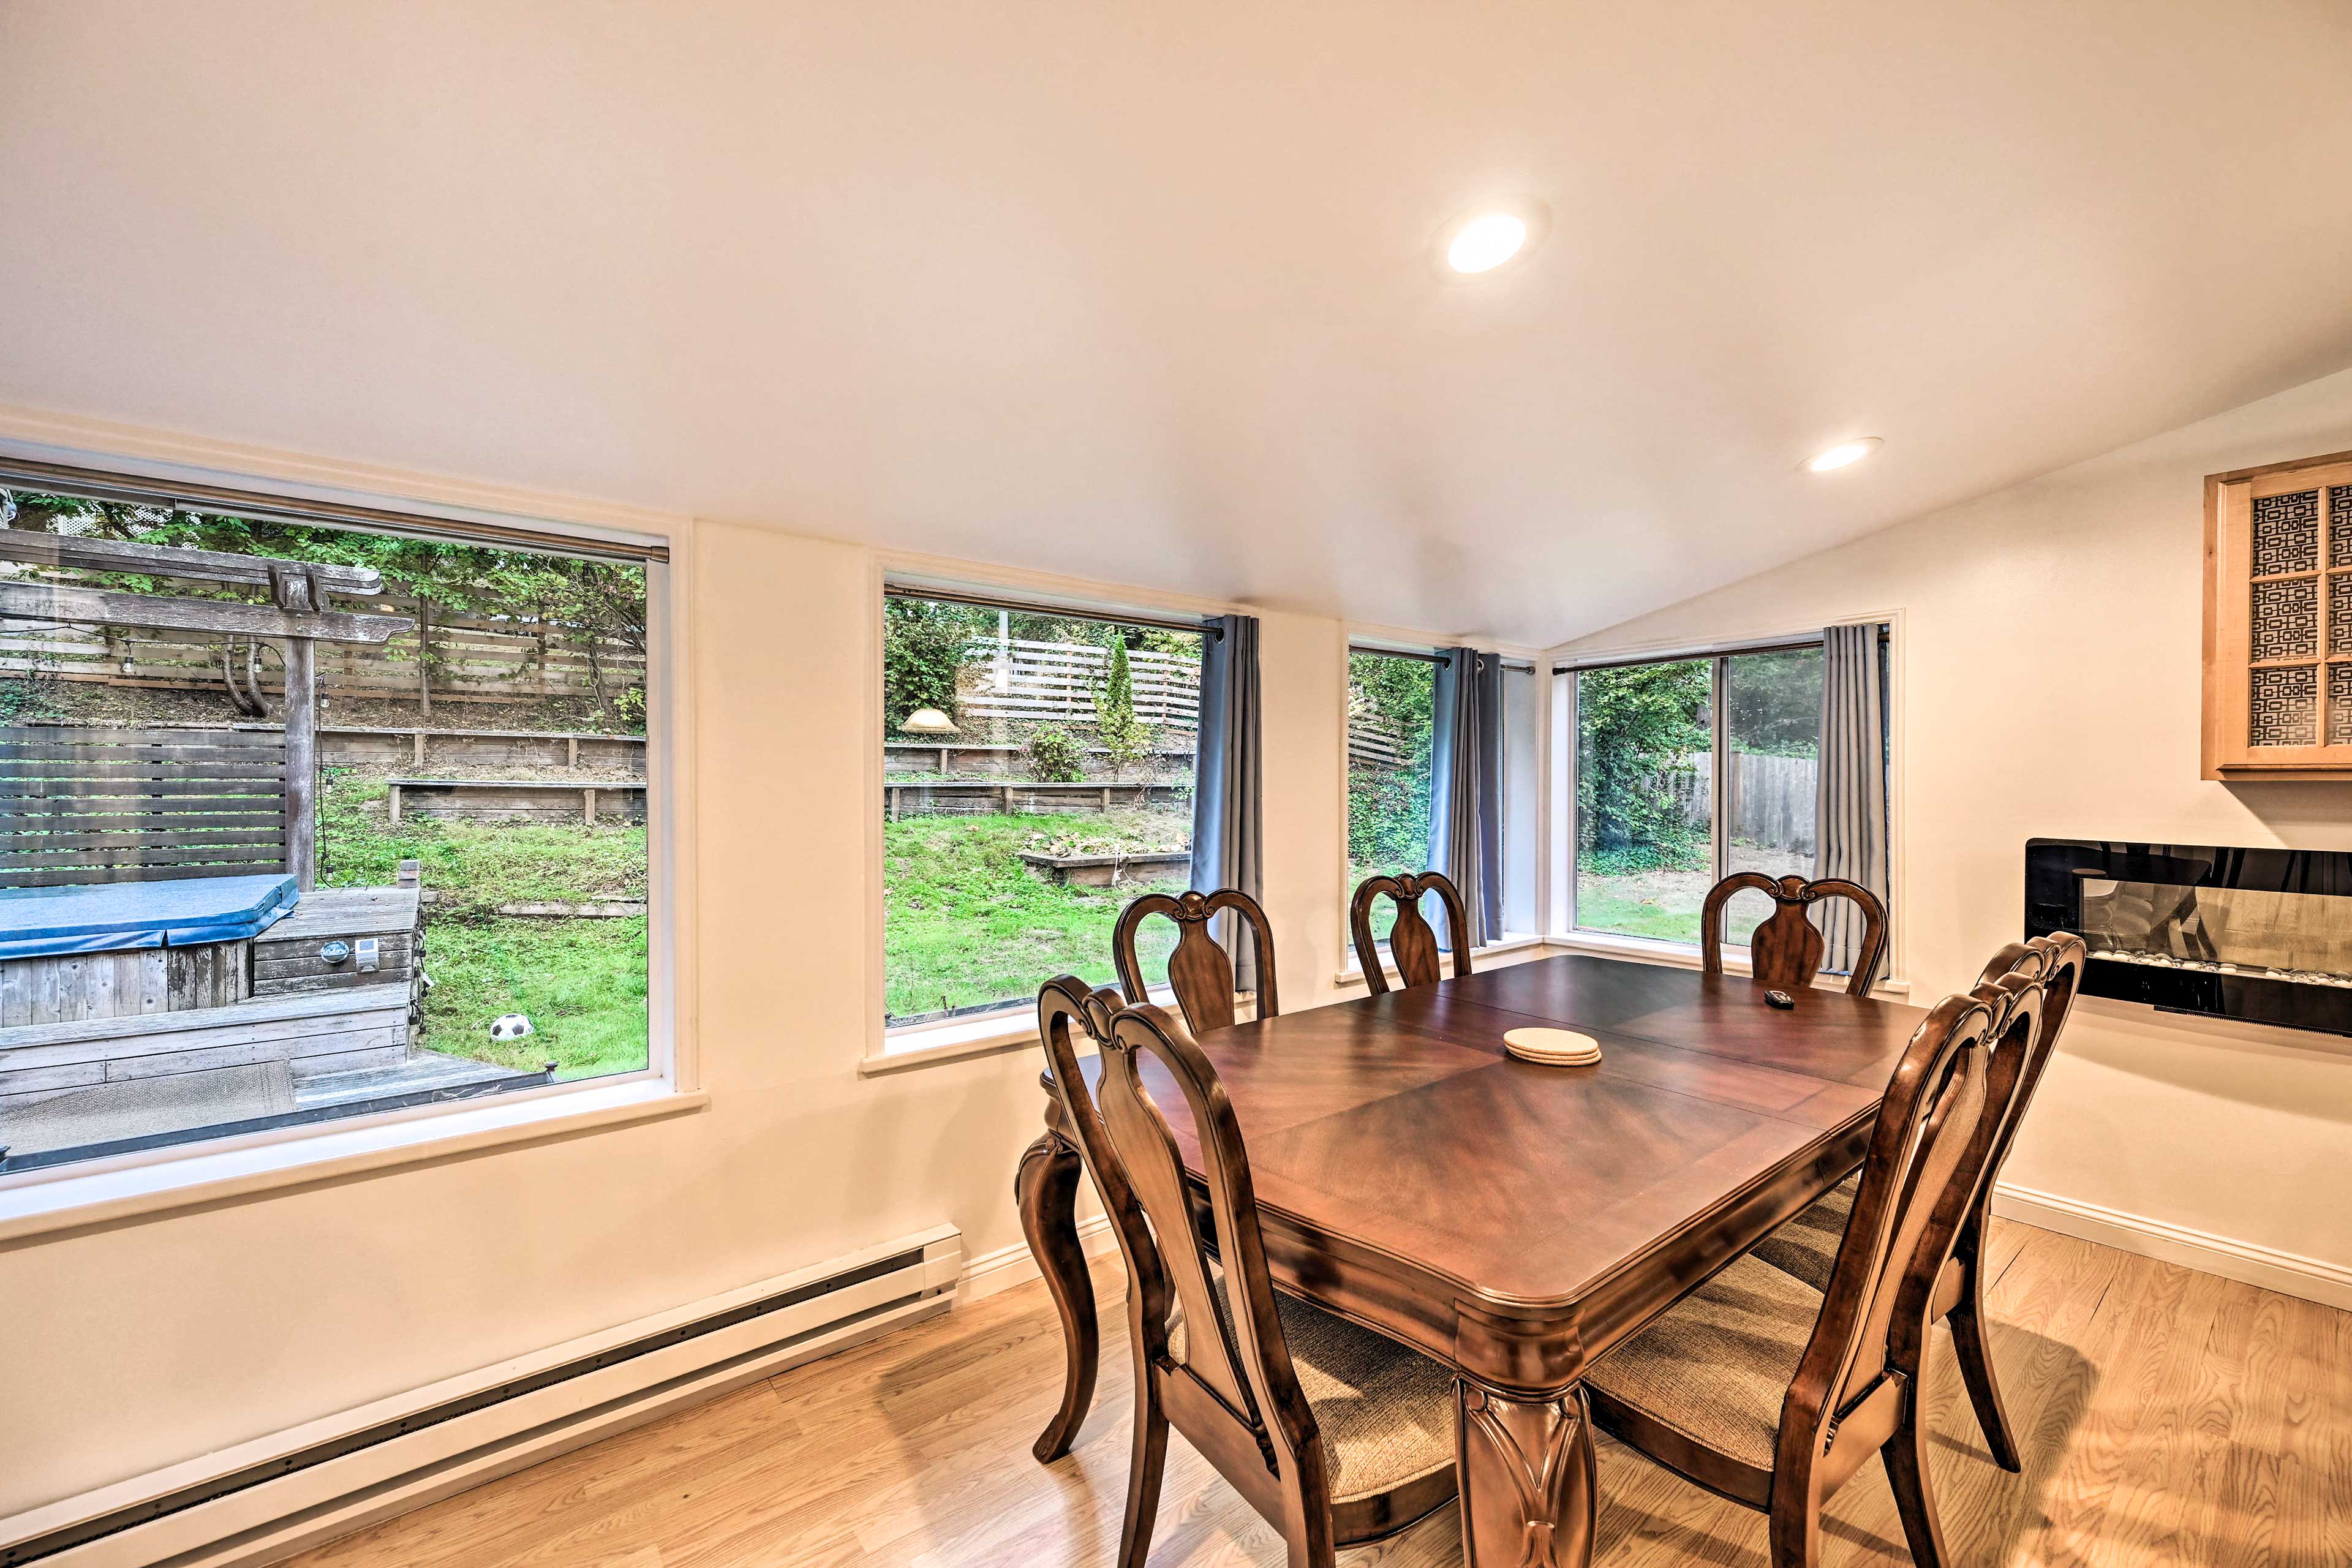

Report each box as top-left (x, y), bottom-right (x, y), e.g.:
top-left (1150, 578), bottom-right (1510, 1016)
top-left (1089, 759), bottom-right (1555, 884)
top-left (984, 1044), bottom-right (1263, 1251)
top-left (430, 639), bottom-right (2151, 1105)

top-left (859, 564), bottom-right (1223, 1077)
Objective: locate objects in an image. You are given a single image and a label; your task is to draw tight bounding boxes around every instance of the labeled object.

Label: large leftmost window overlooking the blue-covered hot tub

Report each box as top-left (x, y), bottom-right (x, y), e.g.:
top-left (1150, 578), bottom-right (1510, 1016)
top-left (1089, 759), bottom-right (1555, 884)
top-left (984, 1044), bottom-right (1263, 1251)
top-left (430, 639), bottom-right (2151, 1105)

top-left (0, 475), bottom-right (666, 1170)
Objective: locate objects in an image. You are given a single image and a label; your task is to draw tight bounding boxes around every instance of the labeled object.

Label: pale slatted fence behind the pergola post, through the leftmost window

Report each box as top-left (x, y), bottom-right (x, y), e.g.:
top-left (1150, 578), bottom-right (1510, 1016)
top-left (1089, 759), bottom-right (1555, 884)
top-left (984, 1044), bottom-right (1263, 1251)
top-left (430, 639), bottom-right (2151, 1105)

top-left (0, 595), bottom-right (644, 703)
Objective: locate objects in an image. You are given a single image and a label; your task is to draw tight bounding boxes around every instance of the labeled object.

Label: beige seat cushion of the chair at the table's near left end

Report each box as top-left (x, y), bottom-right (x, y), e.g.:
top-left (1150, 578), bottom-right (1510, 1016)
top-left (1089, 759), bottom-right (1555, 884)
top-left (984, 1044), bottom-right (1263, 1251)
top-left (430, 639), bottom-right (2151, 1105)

top-left (1169, 1279), bottom-right (1453, 1502)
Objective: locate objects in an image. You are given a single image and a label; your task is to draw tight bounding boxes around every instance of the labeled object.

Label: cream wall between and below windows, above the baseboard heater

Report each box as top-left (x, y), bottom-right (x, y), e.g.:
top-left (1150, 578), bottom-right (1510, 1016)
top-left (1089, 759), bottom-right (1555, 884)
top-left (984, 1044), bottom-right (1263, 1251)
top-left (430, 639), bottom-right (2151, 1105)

top-left (0, 510), bottom-right (1420, 1514)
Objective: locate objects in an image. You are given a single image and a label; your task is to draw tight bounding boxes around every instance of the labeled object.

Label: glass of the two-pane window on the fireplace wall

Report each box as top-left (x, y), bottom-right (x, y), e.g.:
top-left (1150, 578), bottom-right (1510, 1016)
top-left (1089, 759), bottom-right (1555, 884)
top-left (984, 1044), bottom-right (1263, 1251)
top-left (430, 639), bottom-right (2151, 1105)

top-left (1574, 632), bottom-right (1887, 945)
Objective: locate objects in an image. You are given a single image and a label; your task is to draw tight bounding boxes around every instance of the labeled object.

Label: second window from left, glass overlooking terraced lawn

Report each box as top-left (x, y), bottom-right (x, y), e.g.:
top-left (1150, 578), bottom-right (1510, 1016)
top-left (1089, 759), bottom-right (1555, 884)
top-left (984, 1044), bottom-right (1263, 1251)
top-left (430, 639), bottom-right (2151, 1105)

top-left (880, 590), bottom-right (1204, 1030)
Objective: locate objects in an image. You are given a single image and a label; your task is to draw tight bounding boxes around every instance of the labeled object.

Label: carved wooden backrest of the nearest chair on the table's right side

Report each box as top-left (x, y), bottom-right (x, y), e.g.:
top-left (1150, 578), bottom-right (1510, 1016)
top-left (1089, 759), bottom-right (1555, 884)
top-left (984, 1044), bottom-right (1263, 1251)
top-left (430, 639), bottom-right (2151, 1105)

top-left (1773, 976), bottom-right (2041, 1486)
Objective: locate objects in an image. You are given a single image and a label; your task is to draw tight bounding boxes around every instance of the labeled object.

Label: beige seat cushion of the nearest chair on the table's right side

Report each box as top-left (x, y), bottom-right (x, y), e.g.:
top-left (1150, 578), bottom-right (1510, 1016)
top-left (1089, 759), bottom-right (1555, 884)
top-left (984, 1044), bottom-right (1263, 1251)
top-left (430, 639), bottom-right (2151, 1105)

top-left (1590, 1256), bottom-right (1820, 1469)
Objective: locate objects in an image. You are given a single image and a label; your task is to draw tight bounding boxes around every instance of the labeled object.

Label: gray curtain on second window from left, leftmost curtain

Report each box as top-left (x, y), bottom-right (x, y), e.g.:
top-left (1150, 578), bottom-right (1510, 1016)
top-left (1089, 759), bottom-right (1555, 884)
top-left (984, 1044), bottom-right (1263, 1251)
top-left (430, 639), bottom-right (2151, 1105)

top-left (1193, 616), bottom-right (1265, 990)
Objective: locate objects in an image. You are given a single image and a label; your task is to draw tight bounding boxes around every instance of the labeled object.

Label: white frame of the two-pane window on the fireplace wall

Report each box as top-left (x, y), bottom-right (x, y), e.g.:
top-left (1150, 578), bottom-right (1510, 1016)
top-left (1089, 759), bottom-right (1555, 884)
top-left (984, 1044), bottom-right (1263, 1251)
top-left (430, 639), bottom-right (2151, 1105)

top-left (1545, 609), bottom-right (1910, 995)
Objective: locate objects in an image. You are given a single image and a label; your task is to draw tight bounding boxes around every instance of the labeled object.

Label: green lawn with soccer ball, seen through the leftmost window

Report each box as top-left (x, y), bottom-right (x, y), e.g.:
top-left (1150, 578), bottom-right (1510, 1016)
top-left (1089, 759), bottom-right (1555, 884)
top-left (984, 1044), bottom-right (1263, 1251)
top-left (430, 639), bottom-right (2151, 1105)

top-left (320, 769), bottom-right (647, 1079)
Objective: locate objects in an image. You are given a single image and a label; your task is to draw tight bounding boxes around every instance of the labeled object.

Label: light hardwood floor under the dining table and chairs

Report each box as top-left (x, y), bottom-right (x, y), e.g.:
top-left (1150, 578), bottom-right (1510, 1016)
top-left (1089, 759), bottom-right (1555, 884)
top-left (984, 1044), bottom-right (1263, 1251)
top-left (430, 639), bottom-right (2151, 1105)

top-left (296, 1223), bottom-right (2352, 1568)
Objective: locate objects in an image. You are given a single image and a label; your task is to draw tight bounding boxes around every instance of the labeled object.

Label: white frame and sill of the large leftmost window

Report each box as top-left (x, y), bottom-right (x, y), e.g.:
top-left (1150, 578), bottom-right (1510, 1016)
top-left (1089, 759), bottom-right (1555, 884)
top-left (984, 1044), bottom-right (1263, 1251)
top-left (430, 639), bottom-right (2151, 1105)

top-left (0, 435), bottom-right (710, 1242)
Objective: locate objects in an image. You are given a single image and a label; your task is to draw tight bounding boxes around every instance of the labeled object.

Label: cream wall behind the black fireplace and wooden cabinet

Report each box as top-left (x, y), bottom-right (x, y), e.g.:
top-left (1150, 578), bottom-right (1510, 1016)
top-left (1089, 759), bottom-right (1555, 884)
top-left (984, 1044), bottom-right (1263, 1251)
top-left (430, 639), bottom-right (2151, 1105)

top-left (1569, 371), bottom-right (2352, 1279)
